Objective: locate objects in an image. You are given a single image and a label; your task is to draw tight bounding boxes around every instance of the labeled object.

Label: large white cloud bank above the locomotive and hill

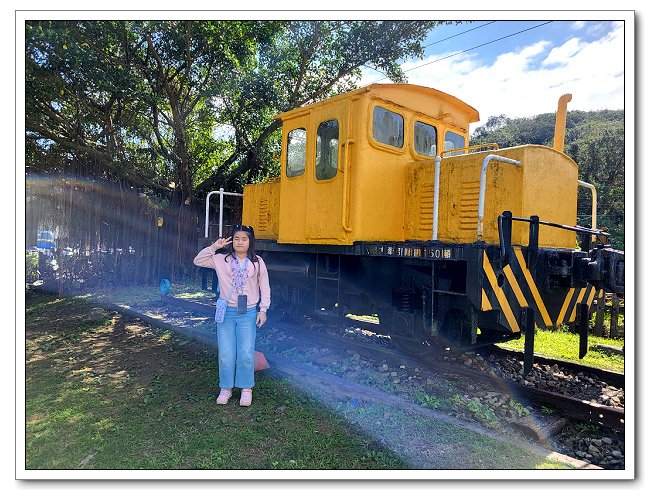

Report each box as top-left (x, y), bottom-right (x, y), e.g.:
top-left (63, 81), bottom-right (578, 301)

top-left (363, 23), bottom-right (624, 130)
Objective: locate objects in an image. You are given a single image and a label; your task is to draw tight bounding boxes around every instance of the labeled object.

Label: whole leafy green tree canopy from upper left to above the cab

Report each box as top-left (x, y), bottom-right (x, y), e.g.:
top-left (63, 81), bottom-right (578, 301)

top-left (25, 20), bottom-right (449, 202)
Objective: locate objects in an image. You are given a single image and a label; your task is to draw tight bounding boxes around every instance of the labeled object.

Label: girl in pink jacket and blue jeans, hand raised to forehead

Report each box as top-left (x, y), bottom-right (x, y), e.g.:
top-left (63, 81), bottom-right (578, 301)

top-left (194, 224), bottom-right (271, 406)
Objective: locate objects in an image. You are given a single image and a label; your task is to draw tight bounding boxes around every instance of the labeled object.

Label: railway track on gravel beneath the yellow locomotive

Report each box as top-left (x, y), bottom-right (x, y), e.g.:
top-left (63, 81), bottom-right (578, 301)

top-left (163, 296), bottom-right (625, 431)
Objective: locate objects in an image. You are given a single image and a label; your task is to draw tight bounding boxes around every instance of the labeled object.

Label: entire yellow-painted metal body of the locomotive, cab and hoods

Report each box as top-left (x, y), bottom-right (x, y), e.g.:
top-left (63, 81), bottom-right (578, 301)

top-left (243, 84), bottom-right (578, 252)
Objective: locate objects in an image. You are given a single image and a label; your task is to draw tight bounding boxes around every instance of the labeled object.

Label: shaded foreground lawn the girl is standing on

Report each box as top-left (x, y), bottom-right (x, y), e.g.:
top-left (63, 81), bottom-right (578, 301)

top-left (25, 294), bottom-right (566, 470)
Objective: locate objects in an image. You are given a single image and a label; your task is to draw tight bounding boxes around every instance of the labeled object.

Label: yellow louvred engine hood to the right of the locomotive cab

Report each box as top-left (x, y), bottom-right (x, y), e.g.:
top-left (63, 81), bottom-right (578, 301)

top-left (405, 145), bottom-right (578, 248)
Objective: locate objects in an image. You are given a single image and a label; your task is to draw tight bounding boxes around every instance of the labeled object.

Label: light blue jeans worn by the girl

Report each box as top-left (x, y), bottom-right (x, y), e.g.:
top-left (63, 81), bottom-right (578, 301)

top-left (217, 307), bottom-right (257, 389)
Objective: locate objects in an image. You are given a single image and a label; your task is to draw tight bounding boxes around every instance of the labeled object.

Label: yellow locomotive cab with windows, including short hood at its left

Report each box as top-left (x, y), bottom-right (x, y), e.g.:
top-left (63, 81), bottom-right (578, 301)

top-left (243, 84), bottom-right (479, 245)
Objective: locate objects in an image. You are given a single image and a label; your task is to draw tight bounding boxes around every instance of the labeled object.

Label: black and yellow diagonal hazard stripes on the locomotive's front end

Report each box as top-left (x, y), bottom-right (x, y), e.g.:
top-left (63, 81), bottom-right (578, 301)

top-left (481, 247), bottom-right (603, 333)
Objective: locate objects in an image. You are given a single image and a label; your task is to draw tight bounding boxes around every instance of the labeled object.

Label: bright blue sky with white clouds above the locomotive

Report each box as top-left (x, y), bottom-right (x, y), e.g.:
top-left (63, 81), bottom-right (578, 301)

top-left (361, 16), bottom-right (625, 130)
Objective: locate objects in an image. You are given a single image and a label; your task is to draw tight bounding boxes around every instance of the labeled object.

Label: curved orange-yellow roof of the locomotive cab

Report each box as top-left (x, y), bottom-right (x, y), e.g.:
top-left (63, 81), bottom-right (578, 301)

top-left (275, 83), bottom-right (479, 123)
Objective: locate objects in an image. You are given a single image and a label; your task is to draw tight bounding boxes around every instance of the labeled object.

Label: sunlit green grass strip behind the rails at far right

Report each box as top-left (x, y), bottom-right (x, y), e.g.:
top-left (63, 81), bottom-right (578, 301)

top-left (499, 329), bottom-right (625, 373)
